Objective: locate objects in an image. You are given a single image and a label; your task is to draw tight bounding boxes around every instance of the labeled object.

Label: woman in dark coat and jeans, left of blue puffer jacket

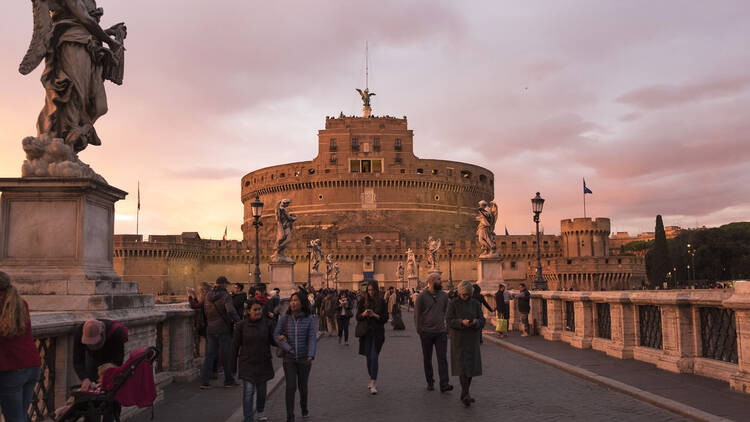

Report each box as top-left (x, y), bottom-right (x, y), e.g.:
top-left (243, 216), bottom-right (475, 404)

top-left (232, 299), bottom-right (276, 422)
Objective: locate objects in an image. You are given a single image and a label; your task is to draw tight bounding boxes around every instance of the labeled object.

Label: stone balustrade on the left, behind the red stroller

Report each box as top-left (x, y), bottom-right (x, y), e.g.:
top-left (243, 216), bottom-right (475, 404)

top-left (29, 303), bottom-right (204, 420)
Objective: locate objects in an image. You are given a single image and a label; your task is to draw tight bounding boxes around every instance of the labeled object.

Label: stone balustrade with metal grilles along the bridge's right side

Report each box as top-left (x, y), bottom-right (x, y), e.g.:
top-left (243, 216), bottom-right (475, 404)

top-left (487, 282), bottom-right (750, 393)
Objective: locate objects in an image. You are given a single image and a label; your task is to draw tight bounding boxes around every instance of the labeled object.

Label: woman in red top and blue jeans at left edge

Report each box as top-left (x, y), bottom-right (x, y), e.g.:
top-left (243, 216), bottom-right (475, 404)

top-left (0, 272), bottom-right (42, 422)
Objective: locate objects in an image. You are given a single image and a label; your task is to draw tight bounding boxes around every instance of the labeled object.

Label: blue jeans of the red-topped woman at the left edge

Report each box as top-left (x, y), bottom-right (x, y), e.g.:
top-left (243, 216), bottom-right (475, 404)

top-left (0, 366), bottom-right (40, 422)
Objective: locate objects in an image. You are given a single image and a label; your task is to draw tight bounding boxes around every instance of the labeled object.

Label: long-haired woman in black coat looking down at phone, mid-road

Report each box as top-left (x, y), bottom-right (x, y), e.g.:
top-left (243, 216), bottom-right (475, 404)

top-left (354, 280), bottom-right (388, 394)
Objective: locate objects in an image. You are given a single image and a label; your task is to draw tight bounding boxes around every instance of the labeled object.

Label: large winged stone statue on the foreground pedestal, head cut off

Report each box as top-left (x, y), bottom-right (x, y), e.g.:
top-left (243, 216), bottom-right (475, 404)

top-left (18, 0), bottom-right (127, 182)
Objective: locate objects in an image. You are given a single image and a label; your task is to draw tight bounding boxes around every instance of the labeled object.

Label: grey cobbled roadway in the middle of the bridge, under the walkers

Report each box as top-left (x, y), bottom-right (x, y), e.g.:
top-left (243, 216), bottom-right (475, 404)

top-left (258, 313), bottom-right (685, 422)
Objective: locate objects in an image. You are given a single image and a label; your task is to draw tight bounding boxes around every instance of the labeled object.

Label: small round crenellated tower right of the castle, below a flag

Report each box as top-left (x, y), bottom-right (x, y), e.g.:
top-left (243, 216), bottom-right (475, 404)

top-left (560, 217), bottom-right (610, 258)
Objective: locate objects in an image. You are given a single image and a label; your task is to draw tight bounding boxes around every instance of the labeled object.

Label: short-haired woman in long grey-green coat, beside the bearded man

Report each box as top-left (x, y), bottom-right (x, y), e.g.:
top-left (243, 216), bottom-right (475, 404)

top-left (445, 281), bottom-right (484, 407)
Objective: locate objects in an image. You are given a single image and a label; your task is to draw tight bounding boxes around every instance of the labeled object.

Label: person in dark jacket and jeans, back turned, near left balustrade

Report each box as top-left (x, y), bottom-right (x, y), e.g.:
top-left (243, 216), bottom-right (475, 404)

top-left (201, 276), bottom-right (240, 389)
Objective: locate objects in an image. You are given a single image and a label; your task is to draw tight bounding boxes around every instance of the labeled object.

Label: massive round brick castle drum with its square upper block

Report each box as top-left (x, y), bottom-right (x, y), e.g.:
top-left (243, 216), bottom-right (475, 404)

top-left (241, 116), bottom-right (494, 252)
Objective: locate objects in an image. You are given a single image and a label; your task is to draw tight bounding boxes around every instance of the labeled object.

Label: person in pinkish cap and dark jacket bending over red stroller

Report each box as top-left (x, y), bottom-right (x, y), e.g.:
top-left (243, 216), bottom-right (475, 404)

top-left (73, 319), bottom-right (128, 422)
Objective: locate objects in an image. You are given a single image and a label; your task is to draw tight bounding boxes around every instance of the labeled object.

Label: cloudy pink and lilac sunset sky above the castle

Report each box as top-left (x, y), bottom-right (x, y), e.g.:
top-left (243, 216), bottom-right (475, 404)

top-left (0, 0), bottom-right (750, 238)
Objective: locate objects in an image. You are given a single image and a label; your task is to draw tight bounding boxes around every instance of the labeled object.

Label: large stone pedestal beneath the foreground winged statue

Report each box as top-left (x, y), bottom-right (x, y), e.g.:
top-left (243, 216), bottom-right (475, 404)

top-left (0, 178), bottom-right (154, 311)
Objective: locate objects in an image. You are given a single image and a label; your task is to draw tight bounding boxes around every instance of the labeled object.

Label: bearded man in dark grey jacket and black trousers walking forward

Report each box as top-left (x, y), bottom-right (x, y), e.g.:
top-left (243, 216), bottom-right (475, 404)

top-left (414, 273), bottom-right (453, 393)
